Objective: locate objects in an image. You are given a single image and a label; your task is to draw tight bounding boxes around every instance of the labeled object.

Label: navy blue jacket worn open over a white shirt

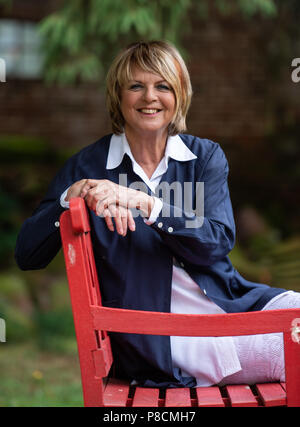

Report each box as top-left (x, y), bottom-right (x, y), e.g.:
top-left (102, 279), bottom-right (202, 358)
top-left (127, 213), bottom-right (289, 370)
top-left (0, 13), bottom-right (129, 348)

top-left (15, 134), bottom-right (285, 387)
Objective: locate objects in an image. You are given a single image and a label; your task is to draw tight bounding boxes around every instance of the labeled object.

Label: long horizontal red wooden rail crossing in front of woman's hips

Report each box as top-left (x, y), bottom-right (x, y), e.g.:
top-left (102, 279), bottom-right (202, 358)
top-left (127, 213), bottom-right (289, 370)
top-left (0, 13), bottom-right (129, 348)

top-left (90, 306), bottom-right (300, 337)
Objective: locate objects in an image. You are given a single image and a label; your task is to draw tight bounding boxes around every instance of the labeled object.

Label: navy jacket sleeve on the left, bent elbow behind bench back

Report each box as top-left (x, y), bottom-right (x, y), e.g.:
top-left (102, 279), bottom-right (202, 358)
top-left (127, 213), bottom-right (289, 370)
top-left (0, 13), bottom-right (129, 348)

top-left (15, 161), bottom-right (74, 270)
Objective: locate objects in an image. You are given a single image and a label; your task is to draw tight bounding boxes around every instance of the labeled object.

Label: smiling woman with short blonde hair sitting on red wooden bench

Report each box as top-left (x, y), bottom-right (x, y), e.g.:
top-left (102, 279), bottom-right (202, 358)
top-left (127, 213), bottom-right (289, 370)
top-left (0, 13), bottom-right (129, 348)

top-left (16, 41), bottom-right (300, 387)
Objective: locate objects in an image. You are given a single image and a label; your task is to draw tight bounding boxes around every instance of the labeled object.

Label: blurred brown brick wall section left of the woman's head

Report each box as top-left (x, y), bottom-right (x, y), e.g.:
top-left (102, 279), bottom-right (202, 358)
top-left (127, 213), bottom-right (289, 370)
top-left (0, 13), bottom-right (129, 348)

top-left (0, 80), bottom-right (110, 148)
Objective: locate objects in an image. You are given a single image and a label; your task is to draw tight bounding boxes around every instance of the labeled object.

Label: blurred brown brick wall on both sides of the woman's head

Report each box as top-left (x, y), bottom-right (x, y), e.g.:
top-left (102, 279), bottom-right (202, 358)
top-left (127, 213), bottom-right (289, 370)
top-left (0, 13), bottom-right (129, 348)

top-left (0, 1), bottom-right (300, 152)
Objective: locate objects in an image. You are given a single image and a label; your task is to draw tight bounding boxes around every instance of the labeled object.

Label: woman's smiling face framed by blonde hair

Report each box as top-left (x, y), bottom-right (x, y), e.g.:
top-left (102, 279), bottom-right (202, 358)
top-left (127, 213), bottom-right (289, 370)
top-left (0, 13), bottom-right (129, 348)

top-left (121, 67), bottom-right (175, 139)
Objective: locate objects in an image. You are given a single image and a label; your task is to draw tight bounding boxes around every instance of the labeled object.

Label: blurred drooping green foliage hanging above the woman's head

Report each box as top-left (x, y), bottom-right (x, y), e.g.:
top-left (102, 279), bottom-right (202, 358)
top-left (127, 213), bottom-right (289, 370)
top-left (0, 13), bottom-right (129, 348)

top-left (40, 0), bottom-right (276, 85)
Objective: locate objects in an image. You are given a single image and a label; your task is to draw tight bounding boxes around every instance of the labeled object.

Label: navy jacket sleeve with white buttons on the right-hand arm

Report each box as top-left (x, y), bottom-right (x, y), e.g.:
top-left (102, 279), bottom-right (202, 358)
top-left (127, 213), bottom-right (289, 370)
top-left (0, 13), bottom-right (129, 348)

top-left (151, 144), bottom-right (235, 266)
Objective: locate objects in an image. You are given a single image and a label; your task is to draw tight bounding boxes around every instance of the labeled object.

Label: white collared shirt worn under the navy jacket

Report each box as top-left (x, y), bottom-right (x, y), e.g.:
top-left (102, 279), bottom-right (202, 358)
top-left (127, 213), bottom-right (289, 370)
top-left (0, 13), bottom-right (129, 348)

top-left (61, 133), bottom-right (241, 387)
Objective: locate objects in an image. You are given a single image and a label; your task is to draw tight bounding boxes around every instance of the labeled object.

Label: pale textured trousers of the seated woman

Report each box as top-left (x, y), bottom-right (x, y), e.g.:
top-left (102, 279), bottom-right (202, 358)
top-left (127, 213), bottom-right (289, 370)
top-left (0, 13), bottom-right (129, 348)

top-left (219, 291), bottom-right (300, 385)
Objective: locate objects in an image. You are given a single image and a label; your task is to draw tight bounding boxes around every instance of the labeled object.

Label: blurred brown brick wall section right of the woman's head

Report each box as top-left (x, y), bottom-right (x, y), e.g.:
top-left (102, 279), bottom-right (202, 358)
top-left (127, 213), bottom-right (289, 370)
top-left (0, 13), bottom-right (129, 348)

top-left (186, 14), bottom-right (300, 144)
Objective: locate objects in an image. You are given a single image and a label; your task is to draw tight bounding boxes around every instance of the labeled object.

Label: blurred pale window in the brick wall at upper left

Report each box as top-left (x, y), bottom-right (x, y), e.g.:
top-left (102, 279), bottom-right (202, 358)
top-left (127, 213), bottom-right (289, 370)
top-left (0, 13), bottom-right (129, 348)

top-left (0, 19), bottom-right (43, 79)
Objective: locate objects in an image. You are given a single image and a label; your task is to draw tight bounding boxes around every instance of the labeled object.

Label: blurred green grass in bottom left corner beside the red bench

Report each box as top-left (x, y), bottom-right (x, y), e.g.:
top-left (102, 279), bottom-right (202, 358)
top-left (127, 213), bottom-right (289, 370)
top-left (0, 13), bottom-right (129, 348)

top-left (0, 341), bottom-right (83, 407)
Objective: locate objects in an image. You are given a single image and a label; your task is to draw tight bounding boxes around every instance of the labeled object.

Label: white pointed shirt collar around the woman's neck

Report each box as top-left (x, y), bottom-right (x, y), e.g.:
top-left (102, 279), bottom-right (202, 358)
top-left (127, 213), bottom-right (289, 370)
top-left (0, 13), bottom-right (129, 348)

top-left (106, 133), bottom-right (197, 169)
